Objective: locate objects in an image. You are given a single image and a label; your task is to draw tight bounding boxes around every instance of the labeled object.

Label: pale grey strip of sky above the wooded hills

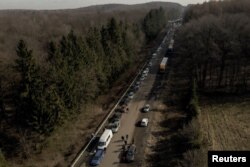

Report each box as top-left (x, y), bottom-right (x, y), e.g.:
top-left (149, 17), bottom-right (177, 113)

top-left (0, 0), bottom-right (209, 10)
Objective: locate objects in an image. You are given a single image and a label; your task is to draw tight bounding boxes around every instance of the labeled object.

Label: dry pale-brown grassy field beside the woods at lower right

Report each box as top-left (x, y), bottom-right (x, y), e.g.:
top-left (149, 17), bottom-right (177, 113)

top-left (200, 97), bottom-right (250, 150)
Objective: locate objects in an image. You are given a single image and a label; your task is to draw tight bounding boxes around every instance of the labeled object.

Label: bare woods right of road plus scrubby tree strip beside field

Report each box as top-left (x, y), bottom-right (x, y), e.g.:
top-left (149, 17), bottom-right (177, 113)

top-left (166, 0), bottom-right (250, 167)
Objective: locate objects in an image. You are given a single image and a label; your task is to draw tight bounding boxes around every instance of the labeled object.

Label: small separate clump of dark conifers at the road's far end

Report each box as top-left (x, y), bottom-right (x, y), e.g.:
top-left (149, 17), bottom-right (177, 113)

top-left (142, 8), bottom-right (167, 41)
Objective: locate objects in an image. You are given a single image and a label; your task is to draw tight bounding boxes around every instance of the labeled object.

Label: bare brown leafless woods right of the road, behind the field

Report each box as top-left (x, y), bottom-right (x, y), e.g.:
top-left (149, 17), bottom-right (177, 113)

top-left (176, 0), bottom-right (250, 93)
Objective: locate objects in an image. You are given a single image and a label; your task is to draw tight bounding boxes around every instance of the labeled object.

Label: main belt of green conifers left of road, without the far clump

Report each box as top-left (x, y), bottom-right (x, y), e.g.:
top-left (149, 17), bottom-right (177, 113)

top-left (10, 18), bottom-right (141, 134)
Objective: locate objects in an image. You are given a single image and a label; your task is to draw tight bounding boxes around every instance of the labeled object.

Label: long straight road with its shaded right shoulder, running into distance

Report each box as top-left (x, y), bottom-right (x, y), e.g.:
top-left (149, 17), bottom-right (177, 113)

top-left (74, 23), bottom-right (173, 167)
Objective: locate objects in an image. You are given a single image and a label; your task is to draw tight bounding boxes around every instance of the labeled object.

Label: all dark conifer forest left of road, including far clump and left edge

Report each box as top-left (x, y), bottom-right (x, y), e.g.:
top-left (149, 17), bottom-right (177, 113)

top-left (0, 5), bottom-right (173, 164)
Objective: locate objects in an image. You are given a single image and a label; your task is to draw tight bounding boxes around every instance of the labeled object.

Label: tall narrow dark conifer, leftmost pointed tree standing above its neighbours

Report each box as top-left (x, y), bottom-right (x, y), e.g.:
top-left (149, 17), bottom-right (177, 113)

top-left (15, 40), bottom-right (42, 125)
